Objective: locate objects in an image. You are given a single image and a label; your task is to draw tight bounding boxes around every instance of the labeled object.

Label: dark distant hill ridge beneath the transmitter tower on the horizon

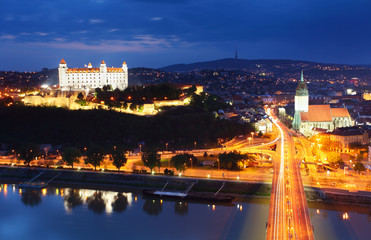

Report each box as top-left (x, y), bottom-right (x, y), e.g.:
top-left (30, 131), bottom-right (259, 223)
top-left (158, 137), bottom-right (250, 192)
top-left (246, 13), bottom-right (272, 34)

top-left (161, 58), bottom-right (326, 72)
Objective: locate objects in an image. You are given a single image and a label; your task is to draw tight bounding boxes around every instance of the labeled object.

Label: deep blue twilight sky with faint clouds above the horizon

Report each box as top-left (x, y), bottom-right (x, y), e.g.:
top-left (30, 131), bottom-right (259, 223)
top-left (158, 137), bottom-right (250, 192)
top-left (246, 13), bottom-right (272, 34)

top-left (0, 0), bottom-right (371, 71)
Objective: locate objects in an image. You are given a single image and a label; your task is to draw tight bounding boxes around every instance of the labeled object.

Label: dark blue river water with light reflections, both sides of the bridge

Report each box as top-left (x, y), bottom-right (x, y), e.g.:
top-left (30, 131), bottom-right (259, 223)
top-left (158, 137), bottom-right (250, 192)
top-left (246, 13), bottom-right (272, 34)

top-left (0, 184), bottom-right (371, 240)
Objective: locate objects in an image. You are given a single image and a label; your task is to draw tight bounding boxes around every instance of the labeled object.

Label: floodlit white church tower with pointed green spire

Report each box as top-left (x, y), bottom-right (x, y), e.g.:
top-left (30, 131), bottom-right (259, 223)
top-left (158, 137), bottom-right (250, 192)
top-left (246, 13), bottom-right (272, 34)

top-left (292, 71), bottom-right (309, 131)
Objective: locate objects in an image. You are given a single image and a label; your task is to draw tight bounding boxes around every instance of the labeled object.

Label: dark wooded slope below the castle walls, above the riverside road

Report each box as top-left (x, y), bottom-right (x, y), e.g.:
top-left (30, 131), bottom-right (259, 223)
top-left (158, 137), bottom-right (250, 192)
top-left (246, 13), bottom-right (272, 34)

top-left (0, 106), bottom-right (253, 150)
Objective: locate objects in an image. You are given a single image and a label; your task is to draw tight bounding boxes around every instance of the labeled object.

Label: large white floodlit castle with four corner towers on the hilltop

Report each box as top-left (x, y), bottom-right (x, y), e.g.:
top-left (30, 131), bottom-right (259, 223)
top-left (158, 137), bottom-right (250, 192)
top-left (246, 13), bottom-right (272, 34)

top-left (58, 59), bottom-right (128, 91)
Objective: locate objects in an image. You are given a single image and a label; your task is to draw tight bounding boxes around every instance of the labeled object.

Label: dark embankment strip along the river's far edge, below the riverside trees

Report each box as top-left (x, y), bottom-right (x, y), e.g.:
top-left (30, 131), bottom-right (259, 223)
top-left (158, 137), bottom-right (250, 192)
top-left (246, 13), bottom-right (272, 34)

top-left (0, 167), bottom-right (371, 204)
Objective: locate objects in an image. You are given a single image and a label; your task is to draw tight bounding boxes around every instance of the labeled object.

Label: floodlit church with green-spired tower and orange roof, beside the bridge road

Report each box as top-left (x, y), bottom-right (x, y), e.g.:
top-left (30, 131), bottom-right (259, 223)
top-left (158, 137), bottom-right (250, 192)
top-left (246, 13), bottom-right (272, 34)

top-left (292, 72), bottom-right (354, 137)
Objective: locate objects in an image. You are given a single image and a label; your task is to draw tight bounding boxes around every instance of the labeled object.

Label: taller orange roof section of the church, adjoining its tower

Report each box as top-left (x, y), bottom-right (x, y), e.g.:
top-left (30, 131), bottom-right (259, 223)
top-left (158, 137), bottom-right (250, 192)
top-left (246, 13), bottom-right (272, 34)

top-left (300, 105), bottom-right (332, 122)
